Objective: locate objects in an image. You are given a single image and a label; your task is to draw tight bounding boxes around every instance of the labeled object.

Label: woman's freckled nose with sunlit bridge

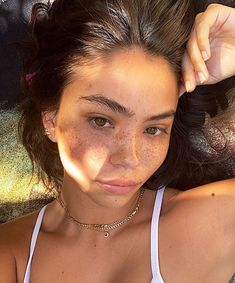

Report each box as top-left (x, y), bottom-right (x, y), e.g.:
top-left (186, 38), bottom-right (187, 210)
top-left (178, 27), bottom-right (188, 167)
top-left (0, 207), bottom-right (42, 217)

top-left (110, 133), bottom-right (141, 168)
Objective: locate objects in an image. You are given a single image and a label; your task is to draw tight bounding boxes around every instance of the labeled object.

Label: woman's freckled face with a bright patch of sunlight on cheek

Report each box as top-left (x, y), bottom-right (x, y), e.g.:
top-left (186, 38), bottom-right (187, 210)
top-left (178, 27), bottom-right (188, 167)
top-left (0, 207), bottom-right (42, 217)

top-left (44, 49), bottom-right (178, 209)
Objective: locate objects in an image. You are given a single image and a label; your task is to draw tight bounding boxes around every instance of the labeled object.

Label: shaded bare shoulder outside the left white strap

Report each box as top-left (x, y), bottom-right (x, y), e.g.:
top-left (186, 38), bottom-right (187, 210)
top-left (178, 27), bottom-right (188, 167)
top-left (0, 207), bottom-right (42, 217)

top-left (0, 211), bottom-right (38, 283)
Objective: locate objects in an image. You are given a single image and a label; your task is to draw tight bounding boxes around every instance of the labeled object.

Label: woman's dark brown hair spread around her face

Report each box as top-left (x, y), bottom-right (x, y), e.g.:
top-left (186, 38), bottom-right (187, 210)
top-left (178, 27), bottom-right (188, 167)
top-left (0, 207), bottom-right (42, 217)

top-left (19, 0), bottom-right (235, 195)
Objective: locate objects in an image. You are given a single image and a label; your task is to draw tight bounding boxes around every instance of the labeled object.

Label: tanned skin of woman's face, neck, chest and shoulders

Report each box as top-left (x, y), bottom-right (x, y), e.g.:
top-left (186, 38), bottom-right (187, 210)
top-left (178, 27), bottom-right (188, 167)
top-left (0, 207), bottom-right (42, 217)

top-left (0, 2), bottom-right (235, 283)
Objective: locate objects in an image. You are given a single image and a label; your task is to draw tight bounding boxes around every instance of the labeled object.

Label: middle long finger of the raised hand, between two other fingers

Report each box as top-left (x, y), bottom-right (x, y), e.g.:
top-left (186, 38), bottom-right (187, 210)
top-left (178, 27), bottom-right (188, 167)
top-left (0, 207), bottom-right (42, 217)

top-left (187, 29), bottom-right (209, 84)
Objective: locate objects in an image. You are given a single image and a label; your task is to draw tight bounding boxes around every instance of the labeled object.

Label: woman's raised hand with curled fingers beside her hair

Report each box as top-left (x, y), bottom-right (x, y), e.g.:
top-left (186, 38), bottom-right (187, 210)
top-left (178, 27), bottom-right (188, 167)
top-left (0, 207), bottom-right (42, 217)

top-left (180, 4), bottom-right (235, 94)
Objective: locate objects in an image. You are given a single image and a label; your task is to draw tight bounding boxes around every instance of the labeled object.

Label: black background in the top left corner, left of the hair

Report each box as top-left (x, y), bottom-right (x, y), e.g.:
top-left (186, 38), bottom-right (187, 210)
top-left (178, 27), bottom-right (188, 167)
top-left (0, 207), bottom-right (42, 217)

top-left (0, 0), bottom-right (46, 107)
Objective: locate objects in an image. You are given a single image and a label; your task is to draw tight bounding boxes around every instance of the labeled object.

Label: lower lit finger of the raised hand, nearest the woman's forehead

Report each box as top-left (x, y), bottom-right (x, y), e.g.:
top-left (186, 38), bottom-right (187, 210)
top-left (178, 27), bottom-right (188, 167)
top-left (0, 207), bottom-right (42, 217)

top-left (182, 51), bottom-right (196, 92)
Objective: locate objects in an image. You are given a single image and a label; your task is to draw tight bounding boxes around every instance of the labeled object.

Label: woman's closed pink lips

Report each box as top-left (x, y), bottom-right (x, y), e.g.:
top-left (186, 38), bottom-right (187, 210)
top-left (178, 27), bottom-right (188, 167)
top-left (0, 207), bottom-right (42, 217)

top-left (97, 180), bottom-right (140, 195)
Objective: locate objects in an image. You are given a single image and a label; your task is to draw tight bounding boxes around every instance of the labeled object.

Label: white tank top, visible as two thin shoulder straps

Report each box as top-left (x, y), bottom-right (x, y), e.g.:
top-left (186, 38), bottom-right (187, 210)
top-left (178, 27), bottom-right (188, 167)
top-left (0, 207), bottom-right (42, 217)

top-left (23, 187), bottom-right (165, 283)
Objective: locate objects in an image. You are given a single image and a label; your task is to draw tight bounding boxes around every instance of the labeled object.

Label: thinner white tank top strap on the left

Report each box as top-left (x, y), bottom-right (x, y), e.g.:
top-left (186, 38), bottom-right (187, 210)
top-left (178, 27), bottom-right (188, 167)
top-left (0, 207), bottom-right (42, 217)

top-left (23, 204), bottom-right (47, 283)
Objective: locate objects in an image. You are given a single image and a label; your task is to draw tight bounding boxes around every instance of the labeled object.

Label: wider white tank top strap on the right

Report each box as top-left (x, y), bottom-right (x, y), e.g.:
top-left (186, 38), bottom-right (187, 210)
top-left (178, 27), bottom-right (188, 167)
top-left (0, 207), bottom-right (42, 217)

top-left (151, 186), bottom-right (165, 283)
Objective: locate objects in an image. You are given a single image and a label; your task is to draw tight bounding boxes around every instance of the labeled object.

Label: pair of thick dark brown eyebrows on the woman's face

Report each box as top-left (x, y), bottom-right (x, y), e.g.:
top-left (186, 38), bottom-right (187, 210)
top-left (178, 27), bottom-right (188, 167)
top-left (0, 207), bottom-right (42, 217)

top-left (78, 95), bottom-right (176, 122)
